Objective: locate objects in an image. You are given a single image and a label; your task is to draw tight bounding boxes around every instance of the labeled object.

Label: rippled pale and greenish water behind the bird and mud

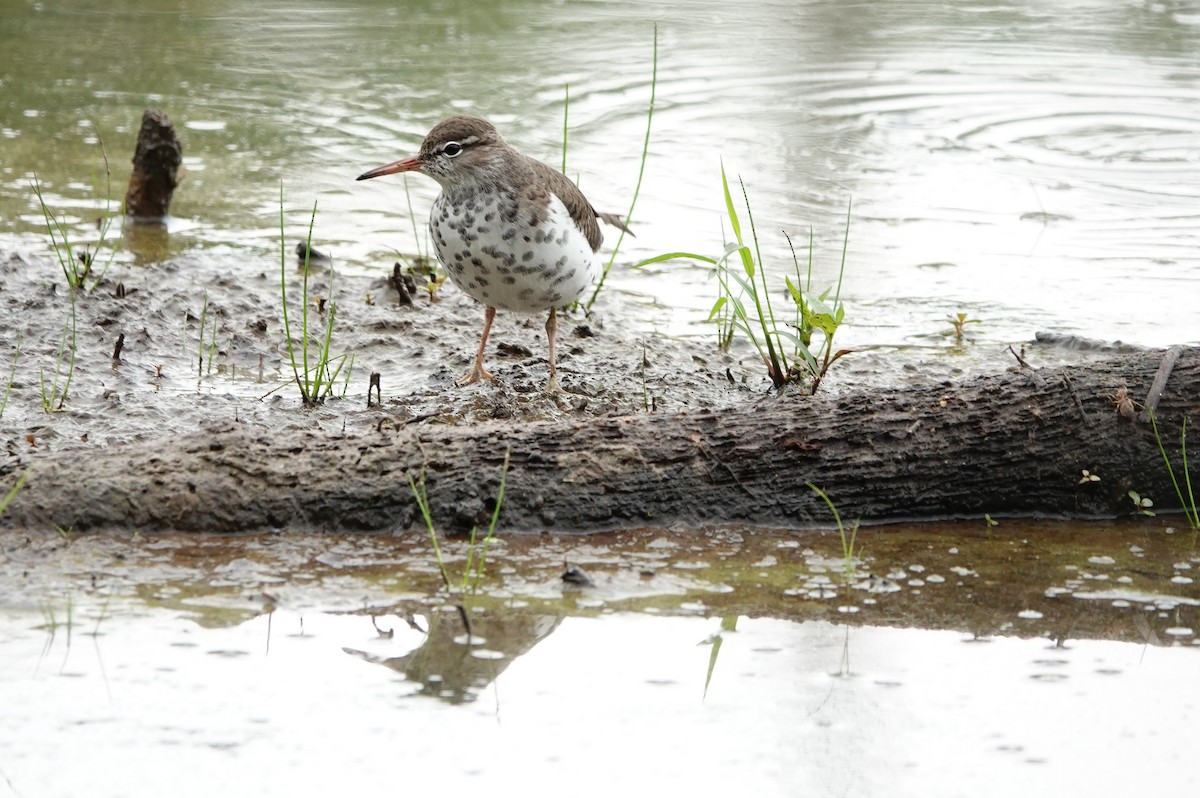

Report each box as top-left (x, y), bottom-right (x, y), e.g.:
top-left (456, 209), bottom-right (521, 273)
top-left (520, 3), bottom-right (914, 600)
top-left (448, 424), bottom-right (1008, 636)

top-left (0, 0), bottom-right (1200, 346)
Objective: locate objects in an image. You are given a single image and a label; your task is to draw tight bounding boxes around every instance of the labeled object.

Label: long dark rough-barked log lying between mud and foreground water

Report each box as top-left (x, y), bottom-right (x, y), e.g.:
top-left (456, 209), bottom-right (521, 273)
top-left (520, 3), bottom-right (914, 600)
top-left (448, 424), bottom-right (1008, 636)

top-left (0, 349), bottom-right (1200, 532)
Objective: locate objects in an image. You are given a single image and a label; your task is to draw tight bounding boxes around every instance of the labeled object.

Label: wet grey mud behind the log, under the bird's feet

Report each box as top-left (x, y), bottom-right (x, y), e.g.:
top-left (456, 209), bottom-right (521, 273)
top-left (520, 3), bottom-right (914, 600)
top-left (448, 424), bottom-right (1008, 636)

top-left (0, 240), bottom-right (984, 523)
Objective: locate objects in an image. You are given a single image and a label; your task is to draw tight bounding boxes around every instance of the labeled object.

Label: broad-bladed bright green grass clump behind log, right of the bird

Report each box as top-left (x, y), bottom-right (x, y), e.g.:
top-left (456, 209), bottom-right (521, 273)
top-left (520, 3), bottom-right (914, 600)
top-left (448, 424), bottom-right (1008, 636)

top-left (635, 164), bottom-right (851, 394)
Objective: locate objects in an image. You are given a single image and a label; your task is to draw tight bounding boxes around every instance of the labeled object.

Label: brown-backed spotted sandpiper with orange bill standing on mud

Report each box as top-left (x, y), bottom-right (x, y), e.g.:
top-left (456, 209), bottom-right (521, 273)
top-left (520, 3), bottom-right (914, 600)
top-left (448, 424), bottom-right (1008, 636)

top-left (358, 116), bottom-right (629, 391)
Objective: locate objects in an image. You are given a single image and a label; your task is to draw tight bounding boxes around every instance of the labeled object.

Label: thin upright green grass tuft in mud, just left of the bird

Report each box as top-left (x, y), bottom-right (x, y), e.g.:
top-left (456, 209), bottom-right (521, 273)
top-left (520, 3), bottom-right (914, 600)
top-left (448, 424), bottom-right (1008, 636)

top-left (278, 184), bottom-right (354, 407)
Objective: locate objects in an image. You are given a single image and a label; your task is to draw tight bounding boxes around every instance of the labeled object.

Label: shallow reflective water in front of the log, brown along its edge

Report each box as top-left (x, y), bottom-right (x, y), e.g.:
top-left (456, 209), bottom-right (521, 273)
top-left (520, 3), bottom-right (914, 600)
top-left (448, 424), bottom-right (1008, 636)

top-left (0, 520), bottom-right (1200, 797)
